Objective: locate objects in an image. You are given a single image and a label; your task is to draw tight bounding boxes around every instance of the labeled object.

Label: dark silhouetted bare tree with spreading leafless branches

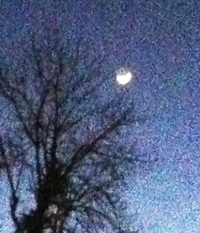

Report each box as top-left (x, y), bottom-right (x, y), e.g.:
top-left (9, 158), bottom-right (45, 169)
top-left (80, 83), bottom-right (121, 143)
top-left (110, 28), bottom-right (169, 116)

top-left (0, 0), bottom-right (142, 233)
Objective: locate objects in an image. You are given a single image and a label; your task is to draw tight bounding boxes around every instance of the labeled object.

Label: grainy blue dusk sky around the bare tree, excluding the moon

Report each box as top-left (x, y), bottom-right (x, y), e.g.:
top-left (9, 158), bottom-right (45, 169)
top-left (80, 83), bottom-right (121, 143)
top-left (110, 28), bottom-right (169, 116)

top-left (0, 0), bottom-right (200, 233)
